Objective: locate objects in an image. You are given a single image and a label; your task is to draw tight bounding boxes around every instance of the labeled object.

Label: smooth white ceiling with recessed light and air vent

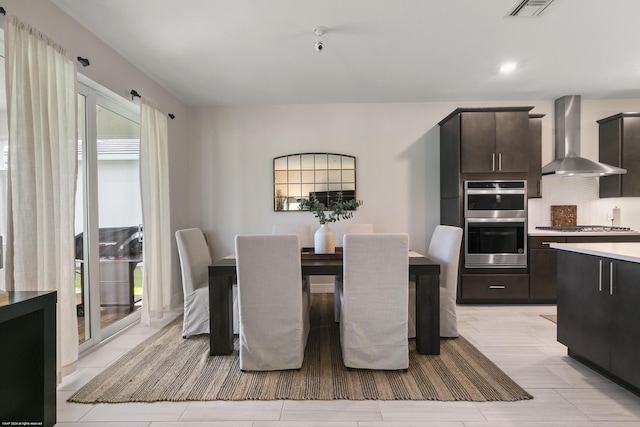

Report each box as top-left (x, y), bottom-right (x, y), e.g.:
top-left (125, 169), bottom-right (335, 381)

top-left (52, 0), bottom-right (640, 106)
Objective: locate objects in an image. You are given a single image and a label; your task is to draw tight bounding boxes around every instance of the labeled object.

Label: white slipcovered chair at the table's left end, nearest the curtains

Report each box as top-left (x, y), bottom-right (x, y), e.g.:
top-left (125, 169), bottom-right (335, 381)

top-left (176, 228), bottom-right (238, 338)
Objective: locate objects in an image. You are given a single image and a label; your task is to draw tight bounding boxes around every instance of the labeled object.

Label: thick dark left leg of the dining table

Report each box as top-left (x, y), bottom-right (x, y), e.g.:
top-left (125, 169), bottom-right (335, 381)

top-left (209, 276), bottom-right (233, 356)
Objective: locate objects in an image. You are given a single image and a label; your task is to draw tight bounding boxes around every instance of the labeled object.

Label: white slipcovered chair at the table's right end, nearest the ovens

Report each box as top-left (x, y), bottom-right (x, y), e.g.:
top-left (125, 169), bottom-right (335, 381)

top-left (408, 225), bottom-right (462, 338)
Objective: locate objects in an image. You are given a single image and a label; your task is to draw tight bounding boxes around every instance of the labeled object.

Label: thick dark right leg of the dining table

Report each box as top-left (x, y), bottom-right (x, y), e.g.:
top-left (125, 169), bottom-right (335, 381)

top-left (416, 274), bottom-right (440, 354)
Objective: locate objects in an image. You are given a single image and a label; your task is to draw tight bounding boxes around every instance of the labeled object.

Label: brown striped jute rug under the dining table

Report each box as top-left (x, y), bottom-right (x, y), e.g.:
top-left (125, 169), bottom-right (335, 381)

top-left (68, 294), bottom-right (532, 403)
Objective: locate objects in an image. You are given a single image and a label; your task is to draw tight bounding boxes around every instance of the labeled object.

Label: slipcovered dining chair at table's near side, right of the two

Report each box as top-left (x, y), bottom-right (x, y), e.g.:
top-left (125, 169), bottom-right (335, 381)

top-left (340, 233), bottom-right (409, 370)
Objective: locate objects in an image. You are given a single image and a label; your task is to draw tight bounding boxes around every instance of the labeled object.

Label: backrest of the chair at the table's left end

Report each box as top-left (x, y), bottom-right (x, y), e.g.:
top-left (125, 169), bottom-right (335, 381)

top-left (176, 228), bottom-right (211, 295)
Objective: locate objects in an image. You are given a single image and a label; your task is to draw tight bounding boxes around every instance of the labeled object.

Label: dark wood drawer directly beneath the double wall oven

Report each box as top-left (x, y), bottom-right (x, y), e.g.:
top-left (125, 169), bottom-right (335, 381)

top-left (461, 274), bottom-right (529, 302)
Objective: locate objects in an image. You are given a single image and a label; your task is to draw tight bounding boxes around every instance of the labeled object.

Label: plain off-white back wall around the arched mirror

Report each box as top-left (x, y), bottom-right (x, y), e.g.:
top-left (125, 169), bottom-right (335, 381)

top-left (190, 102), bottom-right (552, 257)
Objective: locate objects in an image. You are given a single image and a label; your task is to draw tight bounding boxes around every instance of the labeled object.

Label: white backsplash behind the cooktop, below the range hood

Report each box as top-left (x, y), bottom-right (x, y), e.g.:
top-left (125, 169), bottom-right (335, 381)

top-left (528, 175), bottom-right (640, 231)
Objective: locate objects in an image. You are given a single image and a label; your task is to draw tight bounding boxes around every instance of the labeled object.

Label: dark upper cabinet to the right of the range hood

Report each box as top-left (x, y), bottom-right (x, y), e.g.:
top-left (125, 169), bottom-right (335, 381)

top-left (598, 113), bottom-right (640, 197)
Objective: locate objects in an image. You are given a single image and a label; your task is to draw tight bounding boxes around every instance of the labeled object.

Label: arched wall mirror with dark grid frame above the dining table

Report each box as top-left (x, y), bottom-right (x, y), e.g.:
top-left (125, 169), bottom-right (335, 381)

top-left (273, 153), bottom-right (356, 212)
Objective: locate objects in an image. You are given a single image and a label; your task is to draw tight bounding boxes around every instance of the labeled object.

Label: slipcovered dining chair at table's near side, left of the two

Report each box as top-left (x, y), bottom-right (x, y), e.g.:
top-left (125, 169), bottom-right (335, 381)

top-left (236, 234), bottom-right (309, 371)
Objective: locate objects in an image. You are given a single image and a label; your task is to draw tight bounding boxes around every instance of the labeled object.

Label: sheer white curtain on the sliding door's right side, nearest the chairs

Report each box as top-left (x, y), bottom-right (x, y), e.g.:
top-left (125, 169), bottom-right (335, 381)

top-left (140, 98), bottom-right (173, 325)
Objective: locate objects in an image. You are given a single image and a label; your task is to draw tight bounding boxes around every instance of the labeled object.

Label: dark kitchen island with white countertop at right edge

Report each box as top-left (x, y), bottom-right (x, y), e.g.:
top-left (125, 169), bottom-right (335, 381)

top-left (550, 242), bottom-right (640, 394)
